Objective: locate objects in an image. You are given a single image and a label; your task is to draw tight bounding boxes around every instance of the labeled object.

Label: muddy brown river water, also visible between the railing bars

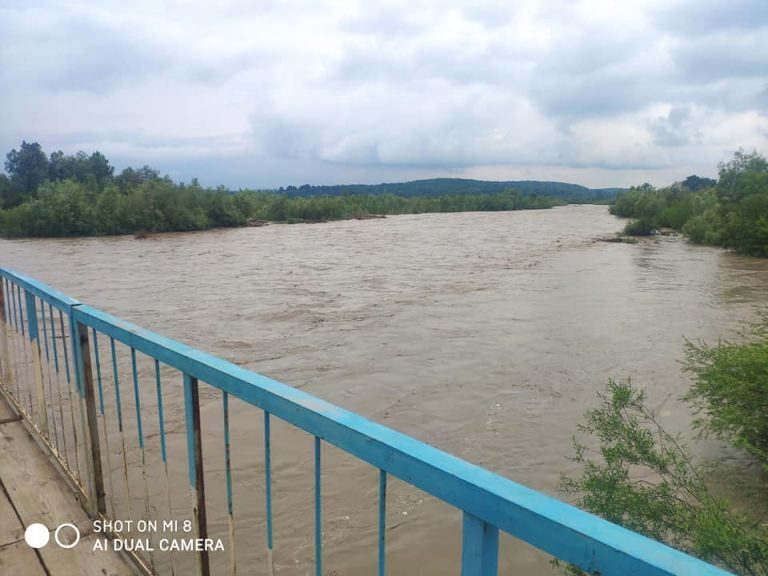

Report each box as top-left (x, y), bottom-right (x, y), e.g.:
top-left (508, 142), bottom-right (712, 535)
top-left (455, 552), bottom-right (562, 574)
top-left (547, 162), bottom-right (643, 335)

top-left (0, 206), bottom-right (768, 575)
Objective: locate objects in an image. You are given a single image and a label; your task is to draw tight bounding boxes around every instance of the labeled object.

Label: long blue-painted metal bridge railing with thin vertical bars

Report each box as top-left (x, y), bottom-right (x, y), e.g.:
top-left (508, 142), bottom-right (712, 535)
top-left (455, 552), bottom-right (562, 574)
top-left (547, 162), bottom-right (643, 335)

top-left (0, 268), bottom-right (727, 576)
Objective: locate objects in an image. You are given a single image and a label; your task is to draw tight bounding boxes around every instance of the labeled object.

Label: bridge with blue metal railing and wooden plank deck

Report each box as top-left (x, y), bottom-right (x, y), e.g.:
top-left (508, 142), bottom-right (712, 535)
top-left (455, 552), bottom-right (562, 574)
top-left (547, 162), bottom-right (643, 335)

top-left (0, 268), bottom-right (728, 576)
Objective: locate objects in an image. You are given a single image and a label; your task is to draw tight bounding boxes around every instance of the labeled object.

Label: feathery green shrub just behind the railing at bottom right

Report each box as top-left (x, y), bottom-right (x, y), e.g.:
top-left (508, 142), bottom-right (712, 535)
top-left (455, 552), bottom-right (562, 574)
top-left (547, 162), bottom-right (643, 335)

top-left (561, 380), bottom-right (768, 575)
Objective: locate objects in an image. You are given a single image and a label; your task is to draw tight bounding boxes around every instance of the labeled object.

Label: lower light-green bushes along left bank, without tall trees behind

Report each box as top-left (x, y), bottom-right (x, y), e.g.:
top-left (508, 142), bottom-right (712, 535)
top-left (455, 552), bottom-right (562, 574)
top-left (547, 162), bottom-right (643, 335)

top-left (0, 180), bottom-right (560, 237)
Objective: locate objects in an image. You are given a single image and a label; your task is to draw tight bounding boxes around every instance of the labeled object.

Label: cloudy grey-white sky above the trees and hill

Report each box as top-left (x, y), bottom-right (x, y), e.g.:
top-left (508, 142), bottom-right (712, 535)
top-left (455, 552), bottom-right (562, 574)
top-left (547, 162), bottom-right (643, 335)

top-left (0, 0), bottom-right (768, 188)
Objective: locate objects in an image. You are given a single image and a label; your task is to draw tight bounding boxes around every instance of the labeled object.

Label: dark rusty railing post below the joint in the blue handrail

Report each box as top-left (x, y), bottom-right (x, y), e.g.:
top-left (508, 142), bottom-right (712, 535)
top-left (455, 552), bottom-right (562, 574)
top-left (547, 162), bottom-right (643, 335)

top-left (75, 322), bottom-right (107, 517)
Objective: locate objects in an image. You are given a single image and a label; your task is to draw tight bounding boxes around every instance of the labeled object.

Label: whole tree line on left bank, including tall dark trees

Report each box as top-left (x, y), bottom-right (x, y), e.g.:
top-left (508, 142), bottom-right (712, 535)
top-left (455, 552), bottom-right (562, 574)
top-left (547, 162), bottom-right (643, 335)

top-left (0, 142), bottom-right (564, 237)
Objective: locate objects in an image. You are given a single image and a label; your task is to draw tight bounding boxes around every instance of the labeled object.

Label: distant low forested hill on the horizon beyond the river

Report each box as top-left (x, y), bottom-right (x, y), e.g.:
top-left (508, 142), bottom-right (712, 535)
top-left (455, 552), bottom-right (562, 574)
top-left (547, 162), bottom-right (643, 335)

top-left (279, 178), bottom-right (621, 202)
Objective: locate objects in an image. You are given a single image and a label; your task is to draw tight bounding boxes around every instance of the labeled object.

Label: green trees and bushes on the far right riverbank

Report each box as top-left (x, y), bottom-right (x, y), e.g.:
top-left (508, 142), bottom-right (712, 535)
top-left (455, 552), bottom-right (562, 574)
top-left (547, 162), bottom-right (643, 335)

top-left (611, 150), bottom-right (768, 257)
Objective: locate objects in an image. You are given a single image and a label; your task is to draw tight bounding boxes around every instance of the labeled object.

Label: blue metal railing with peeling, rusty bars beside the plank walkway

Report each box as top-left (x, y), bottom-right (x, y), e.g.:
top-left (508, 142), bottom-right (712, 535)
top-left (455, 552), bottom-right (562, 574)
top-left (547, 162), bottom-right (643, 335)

top-left (0, 268), bottom-right (727, 576)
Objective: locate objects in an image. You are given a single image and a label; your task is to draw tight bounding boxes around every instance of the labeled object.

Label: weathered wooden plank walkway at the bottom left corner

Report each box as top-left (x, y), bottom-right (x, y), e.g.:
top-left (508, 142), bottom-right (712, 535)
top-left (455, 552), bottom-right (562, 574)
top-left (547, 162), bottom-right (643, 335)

top-left (0, 394), bottom-right (135, 576)
